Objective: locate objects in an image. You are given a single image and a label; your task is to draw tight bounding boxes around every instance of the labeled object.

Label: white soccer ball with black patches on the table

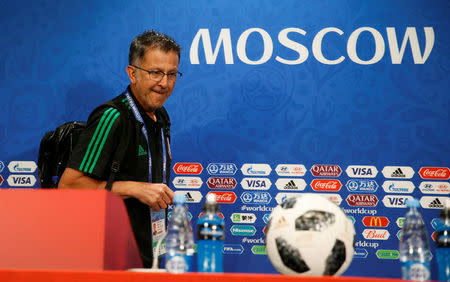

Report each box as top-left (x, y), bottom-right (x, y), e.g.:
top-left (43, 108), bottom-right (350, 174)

top-left (265, 194), bottom-right (355, 276)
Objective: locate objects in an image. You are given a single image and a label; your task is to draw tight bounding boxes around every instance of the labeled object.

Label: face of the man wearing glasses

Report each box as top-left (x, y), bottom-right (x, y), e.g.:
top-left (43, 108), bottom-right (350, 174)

top-left (127, 49), bottom-right (179, 113)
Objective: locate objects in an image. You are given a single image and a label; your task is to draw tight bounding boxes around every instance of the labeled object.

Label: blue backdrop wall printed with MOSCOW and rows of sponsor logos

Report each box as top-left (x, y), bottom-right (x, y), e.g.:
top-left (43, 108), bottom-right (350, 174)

top-left (0, 0), bottom-right (450, 278)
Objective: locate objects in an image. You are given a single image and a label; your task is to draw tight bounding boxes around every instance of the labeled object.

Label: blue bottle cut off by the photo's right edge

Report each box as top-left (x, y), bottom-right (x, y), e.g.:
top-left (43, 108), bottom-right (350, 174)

top-left (436, 199), bottom-right (450, 281)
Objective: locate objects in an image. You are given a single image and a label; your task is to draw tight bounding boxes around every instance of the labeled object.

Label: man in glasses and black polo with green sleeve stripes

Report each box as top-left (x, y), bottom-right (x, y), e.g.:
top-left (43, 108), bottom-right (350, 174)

top-left (58, 31), bottom-right (181, 267)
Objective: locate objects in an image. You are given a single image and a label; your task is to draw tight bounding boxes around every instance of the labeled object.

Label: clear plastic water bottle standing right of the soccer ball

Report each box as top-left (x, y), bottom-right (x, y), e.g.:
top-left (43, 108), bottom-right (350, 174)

top-left (399, 199), bottom-right (431, 281)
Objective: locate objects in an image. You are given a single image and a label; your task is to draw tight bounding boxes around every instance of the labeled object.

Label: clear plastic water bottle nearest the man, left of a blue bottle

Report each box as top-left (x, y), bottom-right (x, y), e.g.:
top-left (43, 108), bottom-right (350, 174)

top-left (166, 194), bottom-right (194, 273)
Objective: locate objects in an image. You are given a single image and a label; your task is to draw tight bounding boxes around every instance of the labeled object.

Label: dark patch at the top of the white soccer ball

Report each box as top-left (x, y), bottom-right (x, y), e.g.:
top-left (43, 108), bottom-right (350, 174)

top-left (295, 210), bottom-right (335, 231)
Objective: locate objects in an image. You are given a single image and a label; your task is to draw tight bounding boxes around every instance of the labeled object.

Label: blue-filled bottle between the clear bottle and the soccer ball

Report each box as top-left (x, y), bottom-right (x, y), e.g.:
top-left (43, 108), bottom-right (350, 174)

top-left (197, 193), bottom-right (225, 272)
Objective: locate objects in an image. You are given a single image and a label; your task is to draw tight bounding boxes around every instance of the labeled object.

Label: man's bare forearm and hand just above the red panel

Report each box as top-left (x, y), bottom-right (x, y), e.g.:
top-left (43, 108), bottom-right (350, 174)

top-left (58, 168), bottom-right (175, 211)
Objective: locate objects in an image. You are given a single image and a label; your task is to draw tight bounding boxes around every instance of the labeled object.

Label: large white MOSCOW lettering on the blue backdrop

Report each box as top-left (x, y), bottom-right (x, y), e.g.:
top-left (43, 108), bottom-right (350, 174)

top-left (189, 27), bottom-right (435, 65)
